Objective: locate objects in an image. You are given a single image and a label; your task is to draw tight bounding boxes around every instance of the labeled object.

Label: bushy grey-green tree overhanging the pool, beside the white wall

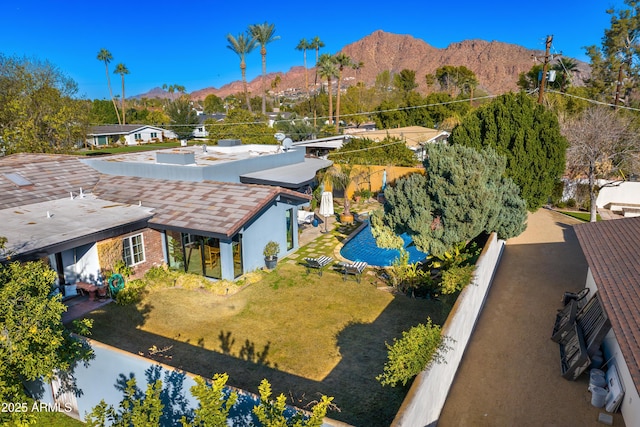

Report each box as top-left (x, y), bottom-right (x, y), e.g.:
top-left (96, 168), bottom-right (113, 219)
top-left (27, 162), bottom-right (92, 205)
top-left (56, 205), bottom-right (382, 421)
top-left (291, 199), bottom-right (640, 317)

top-left (371, 144), bottom-right (527, 256)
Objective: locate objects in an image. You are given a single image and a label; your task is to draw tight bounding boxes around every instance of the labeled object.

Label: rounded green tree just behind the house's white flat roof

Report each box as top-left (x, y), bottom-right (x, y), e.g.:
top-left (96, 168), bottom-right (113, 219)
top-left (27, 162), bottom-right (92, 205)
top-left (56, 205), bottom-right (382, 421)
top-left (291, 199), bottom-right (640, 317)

top-left (205, 109), bottom-right (276, 144)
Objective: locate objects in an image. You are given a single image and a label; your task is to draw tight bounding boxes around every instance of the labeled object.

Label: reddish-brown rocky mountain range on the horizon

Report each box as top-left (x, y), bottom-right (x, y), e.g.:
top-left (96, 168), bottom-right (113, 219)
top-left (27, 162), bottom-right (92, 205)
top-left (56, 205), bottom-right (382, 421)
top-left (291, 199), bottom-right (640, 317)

top-left (142, 30), bottom-right (589, 100)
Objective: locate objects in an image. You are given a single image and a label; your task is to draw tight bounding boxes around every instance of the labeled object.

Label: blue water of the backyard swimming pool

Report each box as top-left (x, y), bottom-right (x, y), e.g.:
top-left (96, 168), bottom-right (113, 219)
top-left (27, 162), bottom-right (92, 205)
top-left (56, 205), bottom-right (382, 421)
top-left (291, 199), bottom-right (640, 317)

top-left (340, 222), bottom-right (427, 267)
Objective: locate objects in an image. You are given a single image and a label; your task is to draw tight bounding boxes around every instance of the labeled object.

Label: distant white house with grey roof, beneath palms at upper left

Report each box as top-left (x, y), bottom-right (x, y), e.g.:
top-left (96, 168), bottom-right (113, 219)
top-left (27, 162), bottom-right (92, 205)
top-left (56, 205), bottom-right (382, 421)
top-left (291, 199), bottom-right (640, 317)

top-left (87, 124), bottom-right (176, 147)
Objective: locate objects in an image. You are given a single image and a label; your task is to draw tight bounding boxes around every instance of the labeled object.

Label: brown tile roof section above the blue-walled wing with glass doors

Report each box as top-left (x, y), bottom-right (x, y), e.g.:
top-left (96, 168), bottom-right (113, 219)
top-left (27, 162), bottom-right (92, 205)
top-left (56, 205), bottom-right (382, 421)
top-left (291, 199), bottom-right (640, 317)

top-left (93, 175), bottom-right (310, 237)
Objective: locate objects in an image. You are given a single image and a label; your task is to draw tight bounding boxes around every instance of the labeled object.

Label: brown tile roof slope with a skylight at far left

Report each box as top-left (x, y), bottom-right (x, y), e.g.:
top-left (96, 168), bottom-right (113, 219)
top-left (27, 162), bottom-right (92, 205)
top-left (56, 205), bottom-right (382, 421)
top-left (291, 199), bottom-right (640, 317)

top-left (0, 154), bottom-right (100, 209)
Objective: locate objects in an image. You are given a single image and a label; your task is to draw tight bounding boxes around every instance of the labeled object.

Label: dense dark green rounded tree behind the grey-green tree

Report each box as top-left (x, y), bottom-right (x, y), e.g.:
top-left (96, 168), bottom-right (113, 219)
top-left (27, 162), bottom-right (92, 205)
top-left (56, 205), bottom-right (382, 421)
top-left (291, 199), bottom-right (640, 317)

top-left (449, 92), bottom-right (567, 211)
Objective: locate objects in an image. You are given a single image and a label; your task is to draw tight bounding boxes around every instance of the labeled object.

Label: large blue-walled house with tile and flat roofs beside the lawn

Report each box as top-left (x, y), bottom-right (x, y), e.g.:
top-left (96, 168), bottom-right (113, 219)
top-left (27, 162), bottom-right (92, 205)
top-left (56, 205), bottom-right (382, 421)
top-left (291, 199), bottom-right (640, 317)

top-left (0, 147), bottom-right (318, 295)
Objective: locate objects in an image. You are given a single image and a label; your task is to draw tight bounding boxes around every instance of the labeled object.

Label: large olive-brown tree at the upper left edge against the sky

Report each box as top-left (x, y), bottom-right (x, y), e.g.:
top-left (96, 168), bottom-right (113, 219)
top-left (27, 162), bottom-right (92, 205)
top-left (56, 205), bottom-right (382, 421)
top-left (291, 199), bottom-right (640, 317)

top-left (0, 54), bottom-right (89, 154)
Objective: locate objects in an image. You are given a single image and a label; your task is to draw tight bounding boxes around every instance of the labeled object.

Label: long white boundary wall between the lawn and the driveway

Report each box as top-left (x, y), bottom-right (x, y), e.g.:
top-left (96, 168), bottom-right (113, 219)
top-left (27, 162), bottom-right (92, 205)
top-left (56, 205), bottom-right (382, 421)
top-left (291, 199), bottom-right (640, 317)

top-left (392, 233), bottom-right (505, 427)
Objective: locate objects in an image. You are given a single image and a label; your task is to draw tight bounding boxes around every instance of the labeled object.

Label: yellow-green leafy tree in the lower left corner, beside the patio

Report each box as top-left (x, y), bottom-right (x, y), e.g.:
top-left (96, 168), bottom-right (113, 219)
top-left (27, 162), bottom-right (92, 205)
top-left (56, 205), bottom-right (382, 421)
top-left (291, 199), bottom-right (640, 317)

top-left (0, 254), bottom-right (93, 425)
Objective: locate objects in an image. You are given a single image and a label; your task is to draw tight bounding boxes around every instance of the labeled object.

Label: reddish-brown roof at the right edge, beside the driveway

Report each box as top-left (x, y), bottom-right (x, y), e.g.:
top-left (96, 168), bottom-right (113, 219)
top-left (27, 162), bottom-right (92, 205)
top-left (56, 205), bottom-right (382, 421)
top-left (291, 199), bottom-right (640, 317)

top-left (574, 217), bottom-right (640, 392)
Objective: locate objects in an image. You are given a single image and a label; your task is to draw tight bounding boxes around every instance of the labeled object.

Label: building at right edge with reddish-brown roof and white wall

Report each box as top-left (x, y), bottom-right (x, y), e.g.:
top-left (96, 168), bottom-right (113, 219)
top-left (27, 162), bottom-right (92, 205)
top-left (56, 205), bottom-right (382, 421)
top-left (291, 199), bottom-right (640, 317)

top-left (574, 218), bottom-right (640, 426)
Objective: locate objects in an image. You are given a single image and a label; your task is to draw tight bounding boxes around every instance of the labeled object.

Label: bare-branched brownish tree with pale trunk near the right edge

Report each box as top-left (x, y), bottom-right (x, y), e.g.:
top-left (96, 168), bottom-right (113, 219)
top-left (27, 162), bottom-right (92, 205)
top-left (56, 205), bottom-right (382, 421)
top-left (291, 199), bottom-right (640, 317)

top-left (562, 106), bottom-right (640, 222)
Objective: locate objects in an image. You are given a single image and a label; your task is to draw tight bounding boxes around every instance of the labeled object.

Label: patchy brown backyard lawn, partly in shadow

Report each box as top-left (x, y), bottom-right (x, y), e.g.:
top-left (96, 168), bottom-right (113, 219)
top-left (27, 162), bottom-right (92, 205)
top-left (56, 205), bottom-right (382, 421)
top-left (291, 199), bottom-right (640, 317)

top-left (85, 262), bottom-right (450, 426)
